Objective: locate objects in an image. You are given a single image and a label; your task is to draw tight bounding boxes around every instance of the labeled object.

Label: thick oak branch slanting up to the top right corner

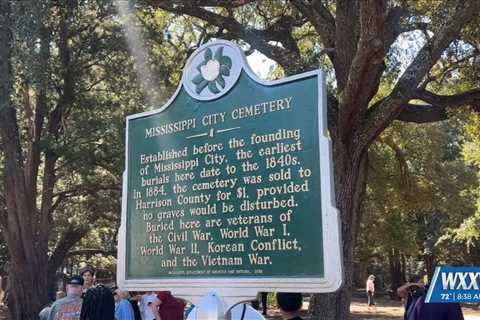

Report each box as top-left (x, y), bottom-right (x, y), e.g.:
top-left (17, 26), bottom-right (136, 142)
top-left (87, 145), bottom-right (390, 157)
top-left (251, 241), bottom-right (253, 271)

top-left (358, 0), bottom-right (480, 148)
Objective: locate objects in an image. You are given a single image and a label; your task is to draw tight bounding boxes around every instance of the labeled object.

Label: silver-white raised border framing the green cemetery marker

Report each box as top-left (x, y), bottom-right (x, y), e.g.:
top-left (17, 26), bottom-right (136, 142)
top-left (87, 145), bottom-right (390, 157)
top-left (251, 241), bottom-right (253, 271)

top-left (117, 40), bottom-right (343, 307)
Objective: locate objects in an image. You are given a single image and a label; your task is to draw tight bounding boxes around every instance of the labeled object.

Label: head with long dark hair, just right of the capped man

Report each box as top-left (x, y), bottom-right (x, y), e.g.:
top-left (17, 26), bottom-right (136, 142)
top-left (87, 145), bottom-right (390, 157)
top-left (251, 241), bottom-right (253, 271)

top-left (80, 286), bottom-right (115, 320)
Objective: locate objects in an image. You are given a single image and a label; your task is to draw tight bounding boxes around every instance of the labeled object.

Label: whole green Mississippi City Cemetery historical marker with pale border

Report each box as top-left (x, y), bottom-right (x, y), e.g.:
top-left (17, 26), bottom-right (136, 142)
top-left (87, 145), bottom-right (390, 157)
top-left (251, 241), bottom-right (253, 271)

top-left (118, 41), bottom-right (342, 301)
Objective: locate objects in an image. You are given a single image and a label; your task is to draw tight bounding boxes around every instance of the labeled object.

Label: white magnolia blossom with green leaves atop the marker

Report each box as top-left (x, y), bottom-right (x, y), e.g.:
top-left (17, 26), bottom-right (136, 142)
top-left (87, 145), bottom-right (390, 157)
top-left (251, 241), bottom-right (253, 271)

top-left (192, 47), bottom-right (232, 94)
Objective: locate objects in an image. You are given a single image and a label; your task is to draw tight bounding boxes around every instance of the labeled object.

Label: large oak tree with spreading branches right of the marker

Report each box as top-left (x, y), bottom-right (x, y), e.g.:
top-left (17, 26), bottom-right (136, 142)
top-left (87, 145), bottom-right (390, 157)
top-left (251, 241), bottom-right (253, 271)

top-left (143, 0), bottom-right (480, 319)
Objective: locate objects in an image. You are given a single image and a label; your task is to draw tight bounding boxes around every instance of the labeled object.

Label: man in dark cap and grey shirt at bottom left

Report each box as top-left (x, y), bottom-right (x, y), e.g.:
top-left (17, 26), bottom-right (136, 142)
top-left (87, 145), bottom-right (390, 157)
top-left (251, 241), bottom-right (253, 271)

top-left (48, 276), bottom-right (83, 320)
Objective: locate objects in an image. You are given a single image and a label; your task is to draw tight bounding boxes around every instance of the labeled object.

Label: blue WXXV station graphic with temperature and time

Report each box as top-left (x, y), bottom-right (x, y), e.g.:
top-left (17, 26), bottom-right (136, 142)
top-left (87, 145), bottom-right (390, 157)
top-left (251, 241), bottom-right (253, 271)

top-left (425, 267), bottom-right (480, 303)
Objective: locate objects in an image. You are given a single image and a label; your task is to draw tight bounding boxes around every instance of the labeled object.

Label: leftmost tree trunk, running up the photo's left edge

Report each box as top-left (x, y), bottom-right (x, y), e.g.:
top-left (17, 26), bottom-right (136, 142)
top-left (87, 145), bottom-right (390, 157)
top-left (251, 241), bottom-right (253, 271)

top-left (0, 0), bottom-right (48, 320)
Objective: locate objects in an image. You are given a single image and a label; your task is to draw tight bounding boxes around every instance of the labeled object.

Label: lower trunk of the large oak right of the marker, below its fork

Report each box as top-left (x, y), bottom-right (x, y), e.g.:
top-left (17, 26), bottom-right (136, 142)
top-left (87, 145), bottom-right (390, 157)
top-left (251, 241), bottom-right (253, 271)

top-left (311, 143), bottom-right (367, 320)
